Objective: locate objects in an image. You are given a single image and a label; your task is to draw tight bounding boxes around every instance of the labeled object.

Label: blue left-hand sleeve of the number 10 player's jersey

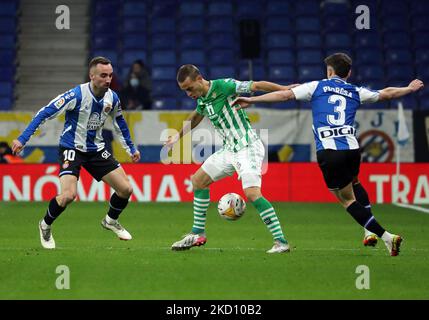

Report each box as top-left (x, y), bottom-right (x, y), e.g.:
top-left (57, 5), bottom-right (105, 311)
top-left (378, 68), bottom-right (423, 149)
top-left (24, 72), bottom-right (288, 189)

top-left (18, 88), bottom-right (81, 145)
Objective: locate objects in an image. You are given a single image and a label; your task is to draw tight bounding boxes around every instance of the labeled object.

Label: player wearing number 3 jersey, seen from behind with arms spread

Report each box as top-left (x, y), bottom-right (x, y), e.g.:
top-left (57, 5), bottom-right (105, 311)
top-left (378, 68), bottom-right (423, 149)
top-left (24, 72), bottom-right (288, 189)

top-left (234, 53), bottom-right (423, 256)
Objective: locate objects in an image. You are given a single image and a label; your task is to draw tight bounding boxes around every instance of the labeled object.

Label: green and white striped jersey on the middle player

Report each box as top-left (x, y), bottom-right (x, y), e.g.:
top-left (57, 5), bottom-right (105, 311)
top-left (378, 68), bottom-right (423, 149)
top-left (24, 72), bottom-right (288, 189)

top-left (196, 79), bottom-right (259, 152)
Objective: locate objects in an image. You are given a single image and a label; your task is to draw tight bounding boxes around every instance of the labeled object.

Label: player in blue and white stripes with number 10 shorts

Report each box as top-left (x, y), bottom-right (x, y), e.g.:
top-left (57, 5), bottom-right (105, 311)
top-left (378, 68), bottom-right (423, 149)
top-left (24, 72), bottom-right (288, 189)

top-left (12, 57), bottom-right (140, 249)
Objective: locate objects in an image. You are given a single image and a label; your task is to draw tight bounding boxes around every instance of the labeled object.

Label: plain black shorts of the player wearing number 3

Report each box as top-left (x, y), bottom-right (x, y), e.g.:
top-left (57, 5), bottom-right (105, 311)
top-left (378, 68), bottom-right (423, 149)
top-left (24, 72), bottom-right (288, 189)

top-left (317, 149), bottom-right (360, 190)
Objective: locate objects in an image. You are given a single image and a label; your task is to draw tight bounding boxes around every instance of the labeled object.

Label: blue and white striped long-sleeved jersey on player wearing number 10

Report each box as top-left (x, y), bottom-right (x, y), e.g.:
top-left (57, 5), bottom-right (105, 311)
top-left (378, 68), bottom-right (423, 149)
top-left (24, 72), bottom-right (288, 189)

top-left (18, 82), bottom-right (136, 155)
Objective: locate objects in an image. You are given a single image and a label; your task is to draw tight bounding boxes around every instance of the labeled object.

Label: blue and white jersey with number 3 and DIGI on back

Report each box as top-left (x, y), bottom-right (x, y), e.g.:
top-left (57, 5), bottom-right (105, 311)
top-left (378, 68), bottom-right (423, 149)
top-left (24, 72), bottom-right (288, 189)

top-left (291, 77), bottom-right (379, 151)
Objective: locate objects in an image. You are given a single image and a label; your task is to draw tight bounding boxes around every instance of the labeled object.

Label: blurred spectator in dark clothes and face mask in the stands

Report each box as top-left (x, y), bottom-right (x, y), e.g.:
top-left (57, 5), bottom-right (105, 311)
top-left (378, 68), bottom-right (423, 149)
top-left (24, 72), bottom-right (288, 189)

top-left (121, 60), bottom-right (152, 110)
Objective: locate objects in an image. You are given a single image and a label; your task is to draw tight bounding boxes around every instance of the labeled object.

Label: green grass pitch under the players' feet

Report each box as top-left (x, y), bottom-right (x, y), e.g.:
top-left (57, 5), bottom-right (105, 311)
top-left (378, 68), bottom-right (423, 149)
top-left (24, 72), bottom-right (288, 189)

top-left (0, 203), bottom-right (429, 300)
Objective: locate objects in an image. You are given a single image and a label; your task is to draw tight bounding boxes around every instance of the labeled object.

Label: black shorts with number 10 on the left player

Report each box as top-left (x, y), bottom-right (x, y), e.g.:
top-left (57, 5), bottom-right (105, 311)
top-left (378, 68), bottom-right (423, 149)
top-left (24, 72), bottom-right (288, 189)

top-left (59, 147), bottom-right (120, 181)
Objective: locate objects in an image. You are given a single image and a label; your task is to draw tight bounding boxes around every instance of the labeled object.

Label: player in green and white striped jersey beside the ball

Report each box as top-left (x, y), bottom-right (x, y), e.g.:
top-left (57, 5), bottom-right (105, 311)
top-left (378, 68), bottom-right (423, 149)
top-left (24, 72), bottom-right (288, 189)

top-left (165, 64), bottom-right (293, 253)
